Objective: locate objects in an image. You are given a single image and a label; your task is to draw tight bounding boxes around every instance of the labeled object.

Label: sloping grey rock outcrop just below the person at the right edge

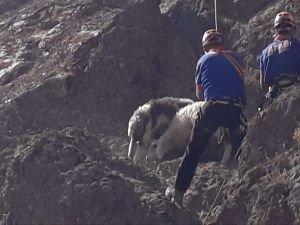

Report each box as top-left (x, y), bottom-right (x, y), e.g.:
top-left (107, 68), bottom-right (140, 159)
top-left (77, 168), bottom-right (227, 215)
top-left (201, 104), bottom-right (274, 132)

top-left (241, 86), bottom-right (300, 170)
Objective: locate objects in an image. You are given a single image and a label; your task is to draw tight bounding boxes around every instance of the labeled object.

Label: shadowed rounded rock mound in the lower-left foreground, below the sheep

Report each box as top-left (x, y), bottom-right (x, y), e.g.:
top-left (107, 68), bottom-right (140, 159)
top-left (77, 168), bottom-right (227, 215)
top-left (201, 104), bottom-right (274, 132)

top-left (0, 128), bottom-right (202, 224)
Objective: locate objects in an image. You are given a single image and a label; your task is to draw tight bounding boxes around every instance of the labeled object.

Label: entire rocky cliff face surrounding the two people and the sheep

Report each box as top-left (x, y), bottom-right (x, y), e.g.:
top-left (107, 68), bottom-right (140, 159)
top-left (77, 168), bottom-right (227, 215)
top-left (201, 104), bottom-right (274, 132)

top-left (0, 0), bottom-right (300, 225)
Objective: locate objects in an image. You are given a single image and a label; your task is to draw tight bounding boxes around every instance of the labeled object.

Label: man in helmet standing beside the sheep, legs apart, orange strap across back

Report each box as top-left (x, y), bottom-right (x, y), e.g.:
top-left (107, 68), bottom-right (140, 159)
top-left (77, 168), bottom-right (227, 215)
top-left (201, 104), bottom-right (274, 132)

top-left (165, 29), bottom-right (247, 206)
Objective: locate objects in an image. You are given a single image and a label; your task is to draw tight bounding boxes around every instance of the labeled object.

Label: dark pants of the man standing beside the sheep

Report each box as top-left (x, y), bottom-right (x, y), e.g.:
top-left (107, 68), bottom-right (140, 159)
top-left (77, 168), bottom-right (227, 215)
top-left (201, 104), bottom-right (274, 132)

top-left (175, 101), bottom-right (247, 192)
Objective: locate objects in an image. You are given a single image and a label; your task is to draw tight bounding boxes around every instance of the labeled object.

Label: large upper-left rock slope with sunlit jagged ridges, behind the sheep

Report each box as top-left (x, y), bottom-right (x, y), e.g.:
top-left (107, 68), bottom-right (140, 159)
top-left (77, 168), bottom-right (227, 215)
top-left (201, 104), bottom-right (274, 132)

top-left (0, 0), bottom-right (196, 137)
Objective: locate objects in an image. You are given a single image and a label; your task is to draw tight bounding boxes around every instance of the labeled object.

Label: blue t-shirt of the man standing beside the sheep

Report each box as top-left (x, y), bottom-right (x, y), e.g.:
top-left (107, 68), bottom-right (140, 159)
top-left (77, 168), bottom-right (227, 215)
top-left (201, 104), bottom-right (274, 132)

top-left (195, 51), bottom-right (245, 101)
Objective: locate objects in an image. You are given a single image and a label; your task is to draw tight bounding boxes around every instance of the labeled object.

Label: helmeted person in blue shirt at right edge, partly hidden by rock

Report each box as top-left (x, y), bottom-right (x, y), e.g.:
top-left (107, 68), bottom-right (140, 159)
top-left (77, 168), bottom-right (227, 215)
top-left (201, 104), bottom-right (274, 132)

top-left (259, 12), bottom-right (300, 110)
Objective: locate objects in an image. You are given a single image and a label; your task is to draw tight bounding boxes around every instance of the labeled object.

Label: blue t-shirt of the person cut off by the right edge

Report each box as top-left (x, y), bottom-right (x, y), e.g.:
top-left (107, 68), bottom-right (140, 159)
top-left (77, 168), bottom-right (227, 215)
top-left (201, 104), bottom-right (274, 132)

top-left (260, 39), bottom-right (300, 84)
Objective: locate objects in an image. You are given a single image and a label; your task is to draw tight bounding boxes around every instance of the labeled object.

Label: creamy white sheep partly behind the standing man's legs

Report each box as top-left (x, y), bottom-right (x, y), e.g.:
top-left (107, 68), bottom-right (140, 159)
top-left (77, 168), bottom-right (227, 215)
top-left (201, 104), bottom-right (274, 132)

top-left (146, 101), bottom-right (232, 164)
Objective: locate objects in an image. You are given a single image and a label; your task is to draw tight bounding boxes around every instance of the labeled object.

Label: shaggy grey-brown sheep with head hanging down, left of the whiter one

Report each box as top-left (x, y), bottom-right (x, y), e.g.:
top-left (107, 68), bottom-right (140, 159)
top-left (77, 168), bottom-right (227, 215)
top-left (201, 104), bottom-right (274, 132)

top-left (128, 97), bottom-right (194, 162)
